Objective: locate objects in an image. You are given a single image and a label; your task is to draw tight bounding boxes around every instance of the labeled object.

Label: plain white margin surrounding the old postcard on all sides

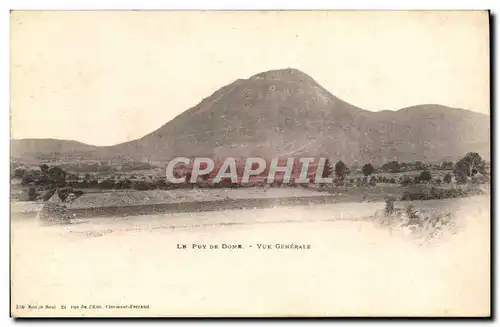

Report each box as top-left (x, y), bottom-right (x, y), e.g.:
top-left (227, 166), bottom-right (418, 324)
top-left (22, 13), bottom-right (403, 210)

top-left (0, 0), bottom-right (500, 325)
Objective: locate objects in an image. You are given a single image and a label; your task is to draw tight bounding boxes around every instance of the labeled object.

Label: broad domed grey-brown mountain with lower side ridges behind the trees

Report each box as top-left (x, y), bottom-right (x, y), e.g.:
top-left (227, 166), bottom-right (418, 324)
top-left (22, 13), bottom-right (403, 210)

top-left (11, 68), bottom-right (490, 167)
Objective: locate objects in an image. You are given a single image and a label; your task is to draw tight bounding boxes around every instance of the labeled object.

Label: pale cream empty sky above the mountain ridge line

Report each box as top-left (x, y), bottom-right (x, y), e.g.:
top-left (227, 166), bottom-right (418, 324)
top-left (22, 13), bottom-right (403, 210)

top-left (10, 11), bottom-right (490, 145)
